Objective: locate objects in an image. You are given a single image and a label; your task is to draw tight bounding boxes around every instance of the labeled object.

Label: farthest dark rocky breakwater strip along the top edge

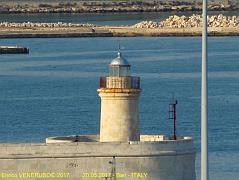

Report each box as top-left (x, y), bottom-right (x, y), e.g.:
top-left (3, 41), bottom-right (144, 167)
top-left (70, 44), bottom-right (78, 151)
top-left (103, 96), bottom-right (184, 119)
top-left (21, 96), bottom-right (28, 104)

top-left (0, 0), bottom-right (239, 13)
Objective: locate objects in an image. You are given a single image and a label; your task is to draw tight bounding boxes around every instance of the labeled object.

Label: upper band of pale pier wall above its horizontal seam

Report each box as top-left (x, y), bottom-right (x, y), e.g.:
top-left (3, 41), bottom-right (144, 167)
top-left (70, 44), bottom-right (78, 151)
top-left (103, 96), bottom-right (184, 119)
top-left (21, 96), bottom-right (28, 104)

top-left (0, 135), bottom-right (195, 159)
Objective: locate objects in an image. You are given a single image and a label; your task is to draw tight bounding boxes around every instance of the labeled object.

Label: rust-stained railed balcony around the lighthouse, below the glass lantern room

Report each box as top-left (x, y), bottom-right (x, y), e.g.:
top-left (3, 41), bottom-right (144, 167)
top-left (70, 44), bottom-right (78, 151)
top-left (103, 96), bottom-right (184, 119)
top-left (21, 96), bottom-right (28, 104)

top-left (100, 76), bottom-right (140, 89)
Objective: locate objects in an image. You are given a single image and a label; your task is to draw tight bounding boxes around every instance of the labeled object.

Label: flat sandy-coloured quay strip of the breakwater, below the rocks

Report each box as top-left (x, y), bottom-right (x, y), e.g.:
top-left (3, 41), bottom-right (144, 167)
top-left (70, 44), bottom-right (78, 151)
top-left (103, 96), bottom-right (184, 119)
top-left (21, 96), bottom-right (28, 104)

top-left (0, 26), bottom-right (239, 38)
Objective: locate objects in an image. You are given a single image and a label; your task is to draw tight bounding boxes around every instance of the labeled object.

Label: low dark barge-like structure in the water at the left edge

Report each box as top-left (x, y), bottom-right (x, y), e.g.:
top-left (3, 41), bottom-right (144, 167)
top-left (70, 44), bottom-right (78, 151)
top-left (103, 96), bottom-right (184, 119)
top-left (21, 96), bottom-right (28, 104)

top-left (0, 46), bottom-right (29, 54)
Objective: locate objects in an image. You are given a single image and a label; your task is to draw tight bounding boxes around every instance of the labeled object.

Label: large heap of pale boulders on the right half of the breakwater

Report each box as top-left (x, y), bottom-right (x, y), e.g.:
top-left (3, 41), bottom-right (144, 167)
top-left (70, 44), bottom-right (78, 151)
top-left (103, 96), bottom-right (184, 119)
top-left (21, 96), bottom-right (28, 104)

top-left (132, 14), bottom-right (239, 29)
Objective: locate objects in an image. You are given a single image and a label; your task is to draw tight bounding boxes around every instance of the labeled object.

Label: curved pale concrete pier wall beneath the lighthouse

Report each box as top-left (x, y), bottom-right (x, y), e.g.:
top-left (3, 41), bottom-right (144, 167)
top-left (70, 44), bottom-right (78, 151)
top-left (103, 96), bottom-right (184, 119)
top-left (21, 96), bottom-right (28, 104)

top-left (0, 136), bottom-right (195, 180)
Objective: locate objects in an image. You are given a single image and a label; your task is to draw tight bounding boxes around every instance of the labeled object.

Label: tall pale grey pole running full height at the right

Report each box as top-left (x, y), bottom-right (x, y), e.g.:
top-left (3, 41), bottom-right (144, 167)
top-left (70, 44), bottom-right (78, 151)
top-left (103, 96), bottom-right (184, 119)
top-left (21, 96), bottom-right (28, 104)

top-left (201, 0), bottom-right (209, 180)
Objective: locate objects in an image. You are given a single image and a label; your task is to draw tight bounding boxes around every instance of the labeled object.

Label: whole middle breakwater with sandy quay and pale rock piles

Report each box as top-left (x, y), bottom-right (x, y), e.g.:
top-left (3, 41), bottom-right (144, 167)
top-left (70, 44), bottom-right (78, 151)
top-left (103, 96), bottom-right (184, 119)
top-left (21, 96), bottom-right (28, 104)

top-left (0, 15), bottom-right (239, 38)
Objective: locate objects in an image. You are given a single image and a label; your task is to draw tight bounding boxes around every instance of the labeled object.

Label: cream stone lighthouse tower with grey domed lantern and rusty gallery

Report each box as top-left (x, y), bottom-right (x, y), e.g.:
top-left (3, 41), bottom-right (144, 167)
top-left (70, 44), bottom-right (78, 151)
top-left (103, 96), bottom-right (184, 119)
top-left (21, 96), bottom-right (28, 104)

top-left (98, 50), bottom-right (141, 142)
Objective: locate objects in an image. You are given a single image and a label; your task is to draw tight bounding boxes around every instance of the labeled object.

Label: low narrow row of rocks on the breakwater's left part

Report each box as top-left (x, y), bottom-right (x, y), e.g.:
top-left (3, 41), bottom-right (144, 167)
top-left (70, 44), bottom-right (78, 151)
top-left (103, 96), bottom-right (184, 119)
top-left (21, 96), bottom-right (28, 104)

top-left (0, 22), bottom-right (96, 28)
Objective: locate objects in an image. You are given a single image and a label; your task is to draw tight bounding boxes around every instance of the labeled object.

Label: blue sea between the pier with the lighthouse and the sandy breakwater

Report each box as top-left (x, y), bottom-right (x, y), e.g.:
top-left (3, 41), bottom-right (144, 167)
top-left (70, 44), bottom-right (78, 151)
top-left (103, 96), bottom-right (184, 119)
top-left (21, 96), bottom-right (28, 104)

top-left (0, 37), bottom-right (239, 180)
